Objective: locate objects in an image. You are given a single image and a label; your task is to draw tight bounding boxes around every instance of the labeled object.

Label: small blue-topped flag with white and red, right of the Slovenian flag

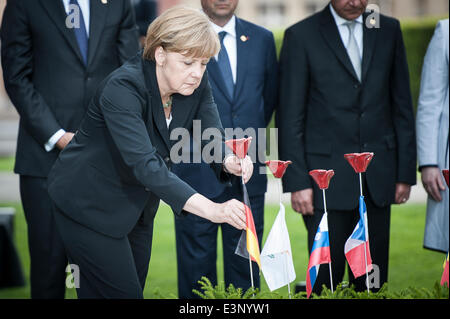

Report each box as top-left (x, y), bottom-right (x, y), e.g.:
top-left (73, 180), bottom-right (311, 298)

top-left (344, 196), bottom-right (372, 278)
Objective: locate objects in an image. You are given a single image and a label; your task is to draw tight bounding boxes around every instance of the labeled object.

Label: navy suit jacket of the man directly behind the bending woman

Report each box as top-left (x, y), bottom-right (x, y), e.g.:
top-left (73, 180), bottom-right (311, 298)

top-left (174, 18), bottom-right (278, 198)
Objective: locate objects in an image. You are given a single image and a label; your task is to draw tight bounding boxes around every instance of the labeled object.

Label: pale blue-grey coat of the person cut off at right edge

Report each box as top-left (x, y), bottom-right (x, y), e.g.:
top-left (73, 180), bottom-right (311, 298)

top-left (416, 19), bottom-right (449, 252)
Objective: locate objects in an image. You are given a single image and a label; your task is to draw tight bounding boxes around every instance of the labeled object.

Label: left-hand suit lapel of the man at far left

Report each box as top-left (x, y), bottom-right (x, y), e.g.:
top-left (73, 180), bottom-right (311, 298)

top-left (40, 0), bottom-right (85, 65)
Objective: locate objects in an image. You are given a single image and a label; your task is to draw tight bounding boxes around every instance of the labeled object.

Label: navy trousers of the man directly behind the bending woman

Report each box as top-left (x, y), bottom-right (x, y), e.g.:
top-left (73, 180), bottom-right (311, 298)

top-left (175, 185), bottom-right (264, 298)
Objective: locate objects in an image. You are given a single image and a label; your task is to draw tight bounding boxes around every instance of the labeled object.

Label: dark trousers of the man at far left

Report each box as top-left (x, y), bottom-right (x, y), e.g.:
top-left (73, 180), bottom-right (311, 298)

top-left (20, 175), bottom-right (67, 299)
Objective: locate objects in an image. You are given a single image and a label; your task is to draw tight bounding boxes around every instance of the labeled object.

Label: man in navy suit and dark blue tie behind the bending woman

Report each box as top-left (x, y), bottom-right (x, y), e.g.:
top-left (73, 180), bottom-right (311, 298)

top-left (174, 0), bottom-right (277, 298)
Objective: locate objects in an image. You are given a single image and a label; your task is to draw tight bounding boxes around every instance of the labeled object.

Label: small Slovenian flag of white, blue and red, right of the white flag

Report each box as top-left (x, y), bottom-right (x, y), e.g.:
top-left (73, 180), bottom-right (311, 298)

top-left (306, 212), bottom-right (331, 298)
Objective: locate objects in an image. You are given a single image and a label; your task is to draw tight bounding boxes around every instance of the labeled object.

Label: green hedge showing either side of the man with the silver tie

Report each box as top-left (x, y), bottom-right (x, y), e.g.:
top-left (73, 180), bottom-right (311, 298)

top-left (271, 17), bottom-right (445, 116)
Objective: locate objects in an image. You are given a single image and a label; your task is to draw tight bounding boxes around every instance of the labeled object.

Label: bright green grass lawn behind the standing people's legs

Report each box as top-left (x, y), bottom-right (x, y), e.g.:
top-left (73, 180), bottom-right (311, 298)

top-left (0, 203), bottom-right (445, 298)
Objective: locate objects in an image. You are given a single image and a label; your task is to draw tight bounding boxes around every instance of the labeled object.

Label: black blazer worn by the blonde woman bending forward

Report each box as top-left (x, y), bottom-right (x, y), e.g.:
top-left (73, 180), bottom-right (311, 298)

top-left (48, 54), bottom-right (230, 237)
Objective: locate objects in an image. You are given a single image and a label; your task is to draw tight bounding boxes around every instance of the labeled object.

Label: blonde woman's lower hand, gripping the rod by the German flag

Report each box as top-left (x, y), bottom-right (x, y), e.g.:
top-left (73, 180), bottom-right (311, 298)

top-left (210, 199), bottom-right (247, 229)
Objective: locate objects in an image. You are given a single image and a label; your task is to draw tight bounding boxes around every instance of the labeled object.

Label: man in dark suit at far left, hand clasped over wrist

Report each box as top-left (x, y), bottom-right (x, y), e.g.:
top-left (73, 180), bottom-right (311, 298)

top-left (1, 0), bottom-right (138, 298)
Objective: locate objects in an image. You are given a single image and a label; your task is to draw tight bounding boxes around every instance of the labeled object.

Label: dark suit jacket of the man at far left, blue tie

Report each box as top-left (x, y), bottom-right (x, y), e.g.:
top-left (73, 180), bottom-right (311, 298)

top-left (1, 0), bottom-right (139, 177)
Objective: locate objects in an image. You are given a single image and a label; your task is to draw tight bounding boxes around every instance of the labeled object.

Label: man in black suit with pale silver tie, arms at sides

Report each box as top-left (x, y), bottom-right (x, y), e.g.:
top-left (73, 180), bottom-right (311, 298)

top-left (276, 0), bottom-right (416, 292)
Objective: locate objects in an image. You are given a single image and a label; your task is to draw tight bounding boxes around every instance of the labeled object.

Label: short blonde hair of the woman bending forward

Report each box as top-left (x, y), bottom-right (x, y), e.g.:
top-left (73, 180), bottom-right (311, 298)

top-left (143, 6), bottom-right (220, 61)
